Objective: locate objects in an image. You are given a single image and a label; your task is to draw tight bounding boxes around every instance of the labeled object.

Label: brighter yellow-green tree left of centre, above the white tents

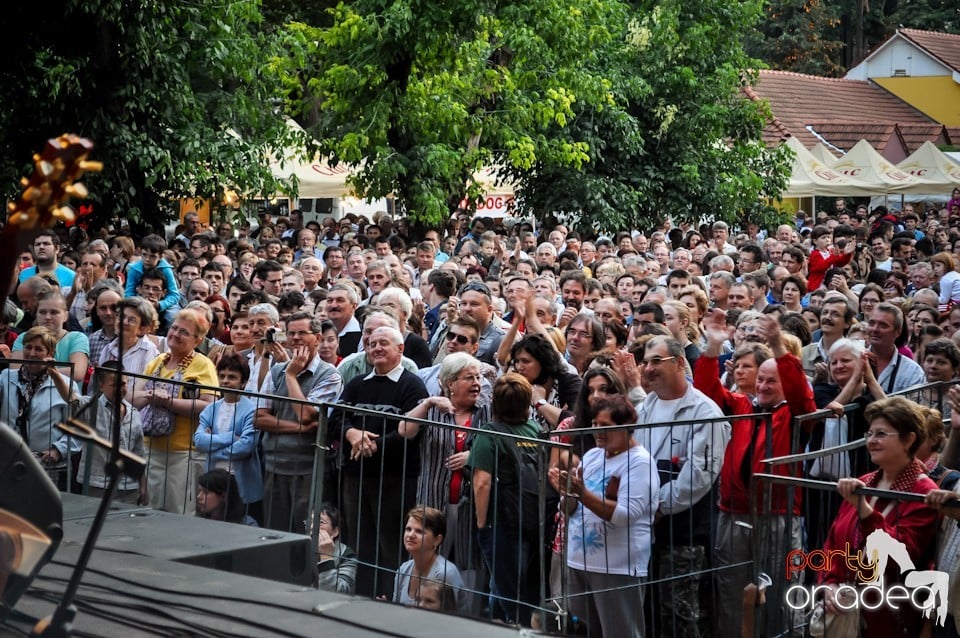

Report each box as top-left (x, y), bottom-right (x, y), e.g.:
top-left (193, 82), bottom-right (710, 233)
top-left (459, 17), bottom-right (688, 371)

top-left (278, 0), bottom-right (623, 224)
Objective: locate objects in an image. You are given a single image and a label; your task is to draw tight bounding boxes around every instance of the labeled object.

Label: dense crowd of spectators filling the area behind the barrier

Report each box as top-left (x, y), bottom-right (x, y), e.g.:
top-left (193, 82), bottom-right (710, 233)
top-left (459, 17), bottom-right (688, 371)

top-left (9, 189), bottom-right (960, 637)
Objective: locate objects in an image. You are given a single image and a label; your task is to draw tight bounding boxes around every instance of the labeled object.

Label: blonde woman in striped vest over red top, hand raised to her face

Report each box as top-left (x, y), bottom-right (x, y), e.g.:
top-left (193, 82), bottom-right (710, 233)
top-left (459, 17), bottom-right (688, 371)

top-left (397, 352), bottom-right (490, 569)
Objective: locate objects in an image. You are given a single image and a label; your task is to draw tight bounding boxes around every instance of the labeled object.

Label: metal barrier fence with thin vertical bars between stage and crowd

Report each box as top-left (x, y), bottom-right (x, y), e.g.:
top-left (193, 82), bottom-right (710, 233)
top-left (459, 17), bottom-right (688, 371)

top-left (18, 362), bottom-right (950, 636)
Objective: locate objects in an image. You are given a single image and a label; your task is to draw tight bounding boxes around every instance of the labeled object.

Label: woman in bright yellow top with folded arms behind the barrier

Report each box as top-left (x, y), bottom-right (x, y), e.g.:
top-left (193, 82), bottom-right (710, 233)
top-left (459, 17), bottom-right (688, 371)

top-left (132, 308), bottom-right (217, 514)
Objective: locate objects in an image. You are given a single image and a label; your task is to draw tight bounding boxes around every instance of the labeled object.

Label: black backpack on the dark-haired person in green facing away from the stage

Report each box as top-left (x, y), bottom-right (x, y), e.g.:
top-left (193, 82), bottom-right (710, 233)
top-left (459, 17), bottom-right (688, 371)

top-left (484, 422), bottom-right (560, 544)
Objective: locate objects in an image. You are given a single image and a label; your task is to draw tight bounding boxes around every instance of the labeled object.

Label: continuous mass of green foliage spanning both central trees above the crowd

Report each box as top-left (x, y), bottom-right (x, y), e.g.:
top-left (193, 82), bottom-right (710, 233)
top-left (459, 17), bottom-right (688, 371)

top-left (277, 0), bottom-right (792, 229)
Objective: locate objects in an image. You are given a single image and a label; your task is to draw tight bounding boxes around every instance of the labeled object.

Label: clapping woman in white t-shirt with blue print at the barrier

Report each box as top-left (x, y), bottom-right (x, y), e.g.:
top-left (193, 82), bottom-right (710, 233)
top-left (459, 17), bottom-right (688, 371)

top-left (550, 396), bottom-right (660, 638)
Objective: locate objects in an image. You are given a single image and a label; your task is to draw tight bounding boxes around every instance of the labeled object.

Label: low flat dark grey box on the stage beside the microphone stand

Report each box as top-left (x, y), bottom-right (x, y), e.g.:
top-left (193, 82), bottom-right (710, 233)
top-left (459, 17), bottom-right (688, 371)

top-left (64, 497), bottom-right (315, 585)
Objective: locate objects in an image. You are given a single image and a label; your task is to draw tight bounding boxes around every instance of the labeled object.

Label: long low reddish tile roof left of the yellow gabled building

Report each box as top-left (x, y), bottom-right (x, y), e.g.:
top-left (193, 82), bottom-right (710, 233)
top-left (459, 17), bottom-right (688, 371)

top-left (744, 70), bottom-right (943, 153)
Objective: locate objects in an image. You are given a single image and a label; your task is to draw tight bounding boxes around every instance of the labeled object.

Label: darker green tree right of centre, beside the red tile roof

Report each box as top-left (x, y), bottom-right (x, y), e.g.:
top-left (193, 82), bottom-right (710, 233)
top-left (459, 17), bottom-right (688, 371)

top-left (506, 0), bottom-right (788, 231)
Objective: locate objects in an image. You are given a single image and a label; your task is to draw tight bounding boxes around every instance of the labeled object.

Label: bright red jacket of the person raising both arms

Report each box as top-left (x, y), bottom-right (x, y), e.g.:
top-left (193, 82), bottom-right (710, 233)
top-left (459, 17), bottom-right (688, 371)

top-left (693, 353), bottom-right (817, 515)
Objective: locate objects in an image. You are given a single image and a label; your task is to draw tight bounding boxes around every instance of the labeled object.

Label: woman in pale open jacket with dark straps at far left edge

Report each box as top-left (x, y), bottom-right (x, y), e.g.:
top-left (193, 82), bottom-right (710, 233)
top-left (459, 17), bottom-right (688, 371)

top-left (0, 326), bottom-right (80, 480)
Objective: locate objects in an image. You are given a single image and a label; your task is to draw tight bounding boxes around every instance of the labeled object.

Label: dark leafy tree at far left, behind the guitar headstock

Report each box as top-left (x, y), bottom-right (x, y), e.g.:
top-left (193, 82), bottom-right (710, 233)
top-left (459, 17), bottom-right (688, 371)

top-left (0, 0), bottom-right (292, 228)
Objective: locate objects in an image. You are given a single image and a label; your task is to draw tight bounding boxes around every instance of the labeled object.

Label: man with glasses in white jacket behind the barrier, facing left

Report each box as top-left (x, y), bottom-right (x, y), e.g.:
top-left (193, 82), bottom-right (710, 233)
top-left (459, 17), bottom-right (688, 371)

top-left (636, 336), bottom-right (730, 636)
